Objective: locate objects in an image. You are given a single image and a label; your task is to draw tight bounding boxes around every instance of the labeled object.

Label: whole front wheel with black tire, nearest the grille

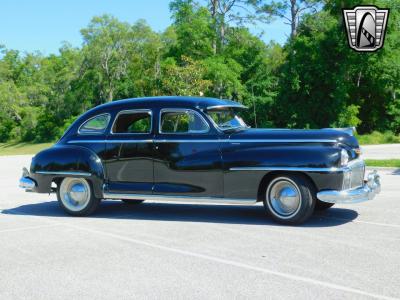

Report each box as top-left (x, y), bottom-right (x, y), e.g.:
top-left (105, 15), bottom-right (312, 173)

top-left (264, 174), bottom-right (315, 225)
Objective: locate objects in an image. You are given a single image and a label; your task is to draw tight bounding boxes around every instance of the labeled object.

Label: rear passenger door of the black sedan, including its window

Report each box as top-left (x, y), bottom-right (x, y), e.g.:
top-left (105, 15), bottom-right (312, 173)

top-left (106, 109), bottom-right (154, 194)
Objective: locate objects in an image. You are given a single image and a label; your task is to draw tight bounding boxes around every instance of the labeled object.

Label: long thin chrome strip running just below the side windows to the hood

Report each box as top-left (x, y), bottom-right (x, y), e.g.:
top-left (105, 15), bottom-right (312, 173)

top-left (68, 139), bottom-right (337, 144)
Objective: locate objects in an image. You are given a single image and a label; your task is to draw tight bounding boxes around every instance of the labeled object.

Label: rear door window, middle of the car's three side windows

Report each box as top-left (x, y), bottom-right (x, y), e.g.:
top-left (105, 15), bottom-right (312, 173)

top-left (112, 110), bottom-right (151, 134)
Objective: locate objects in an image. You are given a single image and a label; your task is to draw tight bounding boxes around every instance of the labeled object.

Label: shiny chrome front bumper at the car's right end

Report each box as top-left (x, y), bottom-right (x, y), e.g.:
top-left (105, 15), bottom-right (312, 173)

top-left (317, 171), bottom-right (381, 203)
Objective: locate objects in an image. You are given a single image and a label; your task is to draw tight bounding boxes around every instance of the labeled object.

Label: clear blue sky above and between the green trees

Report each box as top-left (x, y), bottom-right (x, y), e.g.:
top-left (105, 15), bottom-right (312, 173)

top-left (0, 0), bottom-right (289, 55)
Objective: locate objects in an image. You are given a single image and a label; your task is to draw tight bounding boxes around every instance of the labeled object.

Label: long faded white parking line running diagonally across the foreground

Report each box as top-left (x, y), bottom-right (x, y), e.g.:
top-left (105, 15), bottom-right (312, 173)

top-left (65, 224), bottom-right (399, 300)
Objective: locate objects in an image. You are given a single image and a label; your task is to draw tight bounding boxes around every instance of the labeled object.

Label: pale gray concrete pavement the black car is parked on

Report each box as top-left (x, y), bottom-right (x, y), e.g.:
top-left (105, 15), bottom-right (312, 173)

top-left (0, 156), bottom-right (400, 299)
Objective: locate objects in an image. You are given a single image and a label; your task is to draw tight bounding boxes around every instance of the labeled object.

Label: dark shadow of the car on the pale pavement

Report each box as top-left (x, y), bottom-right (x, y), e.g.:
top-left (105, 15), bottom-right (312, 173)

top-left (2, 201), bottom-right (358, 227)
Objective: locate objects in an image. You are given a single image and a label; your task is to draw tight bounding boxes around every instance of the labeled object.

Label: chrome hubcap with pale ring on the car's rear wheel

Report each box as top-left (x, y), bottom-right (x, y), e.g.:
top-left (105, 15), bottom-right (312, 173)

top-left (60, 178), bottom-right (90, 211)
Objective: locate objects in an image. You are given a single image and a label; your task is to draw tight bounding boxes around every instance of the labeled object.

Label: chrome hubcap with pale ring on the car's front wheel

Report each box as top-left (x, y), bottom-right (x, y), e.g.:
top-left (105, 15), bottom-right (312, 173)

top-left (266, 178), bottom-right (301, 218)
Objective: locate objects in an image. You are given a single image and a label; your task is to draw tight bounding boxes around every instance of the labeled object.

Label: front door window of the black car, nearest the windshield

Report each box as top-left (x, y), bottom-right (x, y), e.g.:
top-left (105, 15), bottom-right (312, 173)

top-left (160, 110), bottom-right (209, 133)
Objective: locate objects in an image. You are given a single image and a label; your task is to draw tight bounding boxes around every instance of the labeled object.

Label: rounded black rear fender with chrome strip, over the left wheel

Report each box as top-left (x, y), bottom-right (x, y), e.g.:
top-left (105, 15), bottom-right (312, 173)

top-left (30, 145), bottom-right (105, 198)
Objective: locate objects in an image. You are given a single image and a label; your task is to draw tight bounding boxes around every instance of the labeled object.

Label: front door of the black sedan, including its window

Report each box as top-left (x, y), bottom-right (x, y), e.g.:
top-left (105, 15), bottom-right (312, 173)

top-left (153, 108), bottom-right (223, 197)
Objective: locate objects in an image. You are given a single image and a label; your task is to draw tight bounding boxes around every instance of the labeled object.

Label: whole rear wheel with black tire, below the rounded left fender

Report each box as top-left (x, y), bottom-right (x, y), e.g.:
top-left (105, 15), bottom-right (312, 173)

top-left (57, 177), bottom-right (100, 216)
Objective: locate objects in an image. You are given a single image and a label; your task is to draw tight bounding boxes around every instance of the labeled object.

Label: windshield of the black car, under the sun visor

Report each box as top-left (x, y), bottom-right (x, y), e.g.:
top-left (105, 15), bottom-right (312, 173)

top-left (207, 107), bottom-right (249, 130)
